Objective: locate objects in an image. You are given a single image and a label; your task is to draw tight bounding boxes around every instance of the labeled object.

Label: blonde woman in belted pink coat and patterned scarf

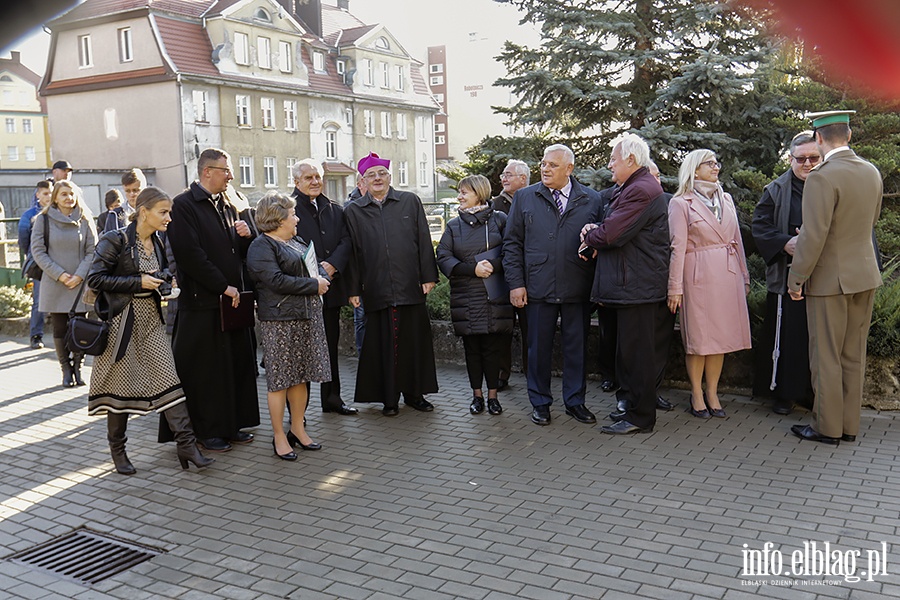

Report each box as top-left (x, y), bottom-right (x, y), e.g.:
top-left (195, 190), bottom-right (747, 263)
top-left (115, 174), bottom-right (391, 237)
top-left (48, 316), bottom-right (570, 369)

top-left (668, 150), bottom-right (750, 419)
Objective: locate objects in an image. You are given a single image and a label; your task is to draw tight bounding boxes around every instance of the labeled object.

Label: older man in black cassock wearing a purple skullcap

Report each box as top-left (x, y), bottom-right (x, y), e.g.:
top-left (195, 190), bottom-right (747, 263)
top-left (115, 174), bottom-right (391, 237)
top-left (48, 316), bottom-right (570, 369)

top-left (344, 153), bottom-right (438, 416)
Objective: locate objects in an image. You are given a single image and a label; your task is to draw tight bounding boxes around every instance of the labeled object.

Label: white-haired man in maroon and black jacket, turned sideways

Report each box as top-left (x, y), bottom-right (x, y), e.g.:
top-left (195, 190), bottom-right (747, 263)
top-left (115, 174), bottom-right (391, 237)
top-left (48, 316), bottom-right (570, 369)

top-left (582, 134), bottom-right (671, 434)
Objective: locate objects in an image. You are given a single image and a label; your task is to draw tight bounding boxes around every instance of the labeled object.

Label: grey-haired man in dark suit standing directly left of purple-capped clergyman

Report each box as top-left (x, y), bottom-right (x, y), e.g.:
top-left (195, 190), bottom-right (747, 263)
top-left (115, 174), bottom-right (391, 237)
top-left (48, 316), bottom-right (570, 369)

top-left (291, 158), bottom-right (359, 415)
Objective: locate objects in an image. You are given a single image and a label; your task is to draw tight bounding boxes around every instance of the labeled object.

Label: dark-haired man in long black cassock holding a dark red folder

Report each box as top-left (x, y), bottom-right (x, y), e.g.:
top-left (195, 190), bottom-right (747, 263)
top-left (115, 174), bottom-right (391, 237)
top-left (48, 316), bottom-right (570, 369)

top-left (166, 148), bottom-right (259, 452)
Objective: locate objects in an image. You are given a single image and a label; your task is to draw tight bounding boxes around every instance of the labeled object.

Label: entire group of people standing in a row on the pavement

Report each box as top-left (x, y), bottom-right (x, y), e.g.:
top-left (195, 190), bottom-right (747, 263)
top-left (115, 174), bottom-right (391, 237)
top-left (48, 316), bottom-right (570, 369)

top-left (23, 106), bottom-right (881, 474)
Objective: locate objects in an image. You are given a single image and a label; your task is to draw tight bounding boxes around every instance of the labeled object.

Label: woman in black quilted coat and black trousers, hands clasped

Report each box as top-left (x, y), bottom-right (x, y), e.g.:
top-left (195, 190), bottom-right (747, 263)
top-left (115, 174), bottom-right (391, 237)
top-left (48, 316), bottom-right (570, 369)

top-left (437, 175), bottom-right (513, 415)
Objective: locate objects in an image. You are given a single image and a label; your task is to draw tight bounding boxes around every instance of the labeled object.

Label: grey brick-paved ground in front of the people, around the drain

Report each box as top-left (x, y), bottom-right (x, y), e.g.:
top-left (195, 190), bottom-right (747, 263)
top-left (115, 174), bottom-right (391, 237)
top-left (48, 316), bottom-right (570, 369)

top-left (0, 338), bottom-right (900, 600)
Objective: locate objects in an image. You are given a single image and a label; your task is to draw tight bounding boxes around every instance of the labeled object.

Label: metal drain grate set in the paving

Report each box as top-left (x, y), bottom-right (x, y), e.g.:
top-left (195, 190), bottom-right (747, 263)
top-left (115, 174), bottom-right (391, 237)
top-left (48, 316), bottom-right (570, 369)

top-left (9, 529), bottom-right (163, 585)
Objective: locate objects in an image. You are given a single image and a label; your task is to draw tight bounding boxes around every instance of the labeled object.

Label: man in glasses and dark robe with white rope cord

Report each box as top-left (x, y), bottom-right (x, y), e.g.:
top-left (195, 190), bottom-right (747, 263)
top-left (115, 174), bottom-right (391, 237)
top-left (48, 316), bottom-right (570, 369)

top-left (752, 131), bottom-right (821, 415)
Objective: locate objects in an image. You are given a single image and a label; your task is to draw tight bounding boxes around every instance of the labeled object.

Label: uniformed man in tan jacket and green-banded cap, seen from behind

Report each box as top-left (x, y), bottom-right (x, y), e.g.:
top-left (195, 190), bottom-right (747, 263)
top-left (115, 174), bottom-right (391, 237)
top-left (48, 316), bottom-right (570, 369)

top-left (788, 111), bottom-right (882, 444)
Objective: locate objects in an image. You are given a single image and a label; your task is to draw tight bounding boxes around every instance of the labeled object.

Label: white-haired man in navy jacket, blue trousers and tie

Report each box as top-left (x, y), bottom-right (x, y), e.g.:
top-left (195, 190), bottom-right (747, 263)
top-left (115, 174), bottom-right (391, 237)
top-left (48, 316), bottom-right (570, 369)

top-left (503, 144), bottom-right (600, 425)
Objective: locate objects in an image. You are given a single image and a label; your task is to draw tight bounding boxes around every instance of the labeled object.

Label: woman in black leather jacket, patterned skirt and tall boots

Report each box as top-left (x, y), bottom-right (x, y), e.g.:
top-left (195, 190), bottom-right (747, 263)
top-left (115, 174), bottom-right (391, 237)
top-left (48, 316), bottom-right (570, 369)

top-left (87, 187), bottom-right (213, 475)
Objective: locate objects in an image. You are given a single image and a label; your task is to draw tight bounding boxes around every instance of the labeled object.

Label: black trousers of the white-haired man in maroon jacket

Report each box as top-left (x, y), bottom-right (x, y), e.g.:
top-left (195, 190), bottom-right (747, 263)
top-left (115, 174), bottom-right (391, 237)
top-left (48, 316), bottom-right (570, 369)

top-left (615, 302), bottom-right (672, 427)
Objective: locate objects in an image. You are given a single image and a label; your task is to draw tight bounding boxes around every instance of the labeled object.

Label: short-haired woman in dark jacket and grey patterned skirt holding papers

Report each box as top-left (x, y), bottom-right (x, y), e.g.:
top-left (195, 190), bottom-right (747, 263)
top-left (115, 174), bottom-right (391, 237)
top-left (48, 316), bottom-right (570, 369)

top-left (247, 192), bottom-right (331, 460)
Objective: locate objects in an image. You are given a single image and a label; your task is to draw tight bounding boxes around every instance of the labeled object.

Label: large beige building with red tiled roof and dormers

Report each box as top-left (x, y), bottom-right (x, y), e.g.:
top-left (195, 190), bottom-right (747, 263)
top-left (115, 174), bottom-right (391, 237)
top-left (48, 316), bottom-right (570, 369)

top-left (41, 0), bottom-right (439, 201)
